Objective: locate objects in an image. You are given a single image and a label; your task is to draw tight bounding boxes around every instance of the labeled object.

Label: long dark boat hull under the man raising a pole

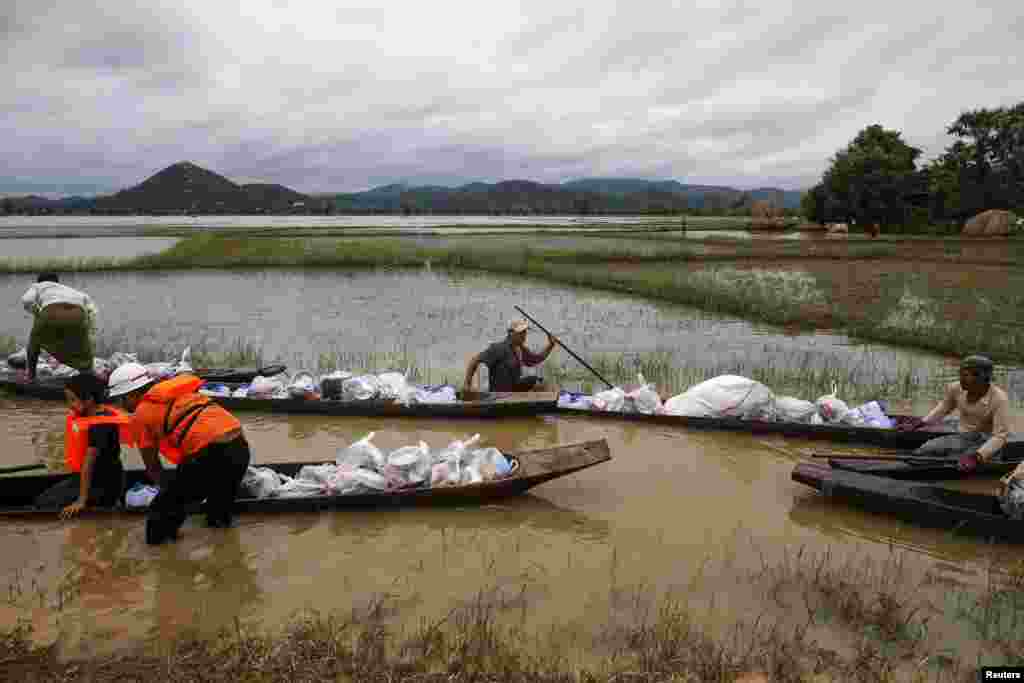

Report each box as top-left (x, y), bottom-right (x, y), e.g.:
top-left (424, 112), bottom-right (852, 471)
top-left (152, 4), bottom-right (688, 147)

top-left (0, 378), bottom-right (558, 418)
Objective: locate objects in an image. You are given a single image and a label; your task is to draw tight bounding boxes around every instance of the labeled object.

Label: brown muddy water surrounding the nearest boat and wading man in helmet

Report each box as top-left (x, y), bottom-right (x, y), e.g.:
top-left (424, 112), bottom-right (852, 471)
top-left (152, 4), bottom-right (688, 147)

top-left (6, 399), bottom-right (1024, 653)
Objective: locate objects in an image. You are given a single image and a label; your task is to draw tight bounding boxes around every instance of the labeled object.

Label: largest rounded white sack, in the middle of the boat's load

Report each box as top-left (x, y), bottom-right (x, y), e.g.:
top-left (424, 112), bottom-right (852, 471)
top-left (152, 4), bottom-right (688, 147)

top-left (665, 375), bottom-right (775, 420)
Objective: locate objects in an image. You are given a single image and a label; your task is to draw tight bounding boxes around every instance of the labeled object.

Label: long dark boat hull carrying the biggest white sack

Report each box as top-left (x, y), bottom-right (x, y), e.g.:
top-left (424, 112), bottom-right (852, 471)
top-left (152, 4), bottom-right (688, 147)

top-left (557, 405), bottom-right (954, 449)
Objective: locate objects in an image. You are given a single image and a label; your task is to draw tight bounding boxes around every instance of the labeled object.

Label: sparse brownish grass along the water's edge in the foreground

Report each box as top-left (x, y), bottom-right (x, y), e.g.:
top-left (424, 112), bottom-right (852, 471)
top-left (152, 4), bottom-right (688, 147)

top-left (0, 548), bottom-right (1024, 683)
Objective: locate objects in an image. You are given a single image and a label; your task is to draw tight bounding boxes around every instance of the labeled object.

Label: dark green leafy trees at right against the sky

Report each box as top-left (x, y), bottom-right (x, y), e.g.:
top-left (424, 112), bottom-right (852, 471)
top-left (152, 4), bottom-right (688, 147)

top-left (801, 102), bottom-right (1024, 230)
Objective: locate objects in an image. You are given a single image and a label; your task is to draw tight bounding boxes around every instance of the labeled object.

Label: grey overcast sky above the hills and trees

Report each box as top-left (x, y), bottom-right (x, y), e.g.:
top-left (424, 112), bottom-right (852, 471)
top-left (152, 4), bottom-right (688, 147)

top-left (0, 0), bottom-right (1024, 195)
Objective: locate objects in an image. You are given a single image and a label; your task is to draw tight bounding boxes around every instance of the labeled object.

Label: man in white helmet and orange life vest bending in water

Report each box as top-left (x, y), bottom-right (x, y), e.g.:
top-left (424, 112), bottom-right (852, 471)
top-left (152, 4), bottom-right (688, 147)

top-left (108, 362), bottom-right (250, 545)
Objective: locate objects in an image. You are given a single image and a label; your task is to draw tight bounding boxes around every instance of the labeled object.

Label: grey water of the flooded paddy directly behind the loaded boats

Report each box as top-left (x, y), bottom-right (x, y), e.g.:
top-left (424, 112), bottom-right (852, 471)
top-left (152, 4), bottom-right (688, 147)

top-left (0, 269), bottom-right (947, 384)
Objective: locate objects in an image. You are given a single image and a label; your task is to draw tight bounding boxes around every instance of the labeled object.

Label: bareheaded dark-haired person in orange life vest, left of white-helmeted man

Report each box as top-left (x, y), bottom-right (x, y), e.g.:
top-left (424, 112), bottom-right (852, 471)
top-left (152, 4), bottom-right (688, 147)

top-left (35, 373), bottom-right (131, 519)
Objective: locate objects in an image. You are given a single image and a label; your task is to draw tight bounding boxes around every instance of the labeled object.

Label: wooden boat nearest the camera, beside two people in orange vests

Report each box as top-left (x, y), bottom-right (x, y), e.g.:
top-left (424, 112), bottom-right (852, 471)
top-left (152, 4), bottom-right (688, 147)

top-left (0, 439), bottom-right (611, 517)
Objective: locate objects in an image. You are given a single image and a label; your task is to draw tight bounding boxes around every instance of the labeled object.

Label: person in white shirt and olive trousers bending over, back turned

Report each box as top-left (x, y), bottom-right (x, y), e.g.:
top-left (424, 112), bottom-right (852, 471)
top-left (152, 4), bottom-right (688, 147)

top-left (22, 272), bottom-right (98, 382)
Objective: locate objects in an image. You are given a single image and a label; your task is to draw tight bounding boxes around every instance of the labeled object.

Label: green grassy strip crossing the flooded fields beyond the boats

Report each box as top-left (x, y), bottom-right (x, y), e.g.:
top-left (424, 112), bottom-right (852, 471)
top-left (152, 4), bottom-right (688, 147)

top-left (7, 234), bottom-right (1024, 361)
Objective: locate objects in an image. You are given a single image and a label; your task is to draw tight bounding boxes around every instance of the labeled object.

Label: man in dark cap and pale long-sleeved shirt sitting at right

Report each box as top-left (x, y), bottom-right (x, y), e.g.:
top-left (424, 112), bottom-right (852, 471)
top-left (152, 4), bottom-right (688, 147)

top-left (900, 355), bottom-right (1010, 469)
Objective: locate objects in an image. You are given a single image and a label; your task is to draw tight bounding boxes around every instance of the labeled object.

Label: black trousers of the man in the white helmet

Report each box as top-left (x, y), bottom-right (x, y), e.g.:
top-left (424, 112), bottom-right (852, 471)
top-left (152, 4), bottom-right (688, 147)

top-left (145, 436), bottom-right (251, 545)
